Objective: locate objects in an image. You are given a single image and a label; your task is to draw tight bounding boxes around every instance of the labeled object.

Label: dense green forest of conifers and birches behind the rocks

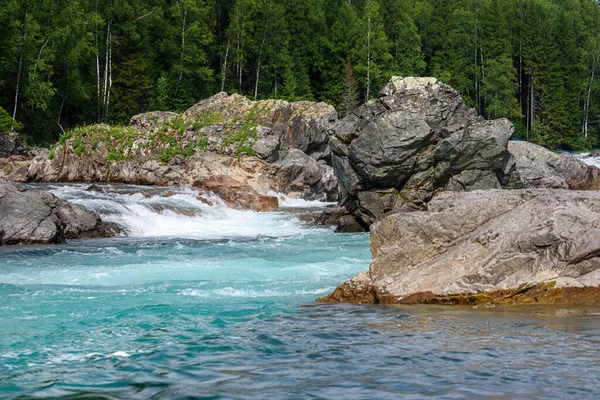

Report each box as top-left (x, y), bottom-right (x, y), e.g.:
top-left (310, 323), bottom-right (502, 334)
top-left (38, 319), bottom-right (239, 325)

top-left (0, 0), bottom-right (600, 150)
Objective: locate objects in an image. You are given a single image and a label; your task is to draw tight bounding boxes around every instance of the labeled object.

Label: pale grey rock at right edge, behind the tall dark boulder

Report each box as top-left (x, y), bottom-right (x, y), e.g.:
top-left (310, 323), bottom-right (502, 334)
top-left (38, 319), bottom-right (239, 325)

top-left (508, 141), bottom-right (600, 190)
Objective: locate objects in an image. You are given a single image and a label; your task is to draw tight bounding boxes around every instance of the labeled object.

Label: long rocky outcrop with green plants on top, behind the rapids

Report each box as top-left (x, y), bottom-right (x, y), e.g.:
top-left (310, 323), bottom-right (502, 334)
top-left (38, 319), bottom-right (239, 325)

top-left (0, 93), bottom-right (338, 201)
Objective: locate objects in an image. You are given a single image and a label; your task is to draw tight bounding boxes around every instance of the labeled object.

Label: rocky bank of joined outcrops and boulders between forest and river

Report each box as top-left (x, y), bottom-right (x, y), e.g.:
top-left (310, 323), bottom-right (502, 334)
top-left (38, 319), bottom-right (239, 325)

top-left (0, 77), bottom-right (600, 304)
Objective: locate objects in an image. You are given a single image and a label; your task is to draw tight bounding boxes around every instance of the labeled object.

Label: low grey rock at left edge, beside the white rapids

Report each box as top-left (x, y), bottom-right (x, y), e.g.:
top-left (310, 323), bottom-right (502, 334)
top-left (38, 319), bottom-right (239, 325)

top-left (0, 182), bottom-right (120, 245)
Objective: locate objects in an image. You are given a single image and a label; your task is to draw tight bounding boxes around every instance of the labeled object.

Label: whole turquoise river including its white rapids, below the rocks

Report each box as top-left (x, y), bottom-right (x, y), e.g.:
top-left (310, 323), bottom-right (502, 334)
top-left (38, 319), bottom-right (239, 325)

top-left (0, 186), bottom-right (600, 399)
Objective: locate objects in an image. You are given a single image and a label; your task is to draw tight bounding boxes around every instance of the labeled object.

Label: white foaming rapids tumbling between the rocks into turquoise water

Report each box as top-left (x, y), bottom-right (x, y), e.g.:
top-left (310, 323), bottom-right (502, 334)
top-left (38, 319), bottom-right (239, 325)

top-left (44, 185), bottom-right (329, 240)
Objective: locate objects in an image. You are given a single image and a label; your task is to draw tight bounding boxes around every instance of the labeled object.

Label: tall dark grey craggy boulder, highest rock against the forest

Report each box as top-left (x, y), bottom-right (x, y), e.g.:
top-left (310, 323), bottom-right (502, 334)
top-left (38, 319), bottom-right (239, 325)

top-left (330, 77), bottom-right (513, 225)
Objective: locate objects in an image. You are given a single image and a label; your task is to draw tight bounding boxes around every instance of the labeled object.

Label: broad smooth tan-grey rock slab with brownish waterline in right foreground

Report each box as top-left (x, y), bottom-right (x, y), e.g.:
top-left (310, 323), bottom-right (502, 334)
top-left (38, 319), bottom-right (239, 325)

top-left (325, 189), bottom-right (600, 304)
